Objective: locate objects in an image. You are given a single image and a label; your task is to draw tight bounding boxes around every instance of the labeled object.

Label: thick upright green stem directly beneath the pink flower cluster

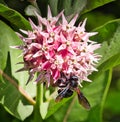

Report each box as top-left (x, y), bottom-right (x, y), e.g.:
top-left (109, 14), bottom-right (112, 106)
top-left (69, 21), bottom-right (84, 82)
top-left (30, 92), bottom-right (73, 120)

top-left (34, 83), bottom-right (43, 122)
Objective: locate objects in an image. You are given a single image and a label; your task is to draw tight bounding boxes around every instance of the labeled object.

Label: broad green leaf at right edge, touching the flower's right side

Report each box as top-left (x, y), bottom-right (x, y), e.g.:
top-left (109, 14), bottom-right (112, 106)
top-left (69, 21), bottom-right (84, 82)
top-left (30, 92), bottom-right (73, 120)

top-left (93, 19), bottom-right (120, 71)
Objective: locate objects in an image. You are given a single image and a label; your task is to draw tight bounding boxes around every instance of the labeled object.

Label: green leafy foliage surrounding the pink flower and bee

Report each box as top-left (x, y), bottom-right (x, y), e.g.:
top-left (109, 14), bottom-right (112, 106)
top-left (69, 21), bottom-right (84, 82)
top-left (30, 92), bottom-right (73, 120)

top-left (0, 0), bottom-right (120, 122)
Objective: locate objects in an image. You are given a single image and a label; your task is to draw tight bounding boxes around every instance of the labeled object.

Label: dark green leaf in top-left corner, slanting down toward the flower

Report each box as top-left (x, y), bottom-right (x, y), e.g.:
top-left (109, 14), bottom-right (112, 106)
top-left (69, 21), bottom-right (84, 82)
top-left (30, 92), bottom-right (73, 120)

top-left (0, 4), bottom-right (31, 29)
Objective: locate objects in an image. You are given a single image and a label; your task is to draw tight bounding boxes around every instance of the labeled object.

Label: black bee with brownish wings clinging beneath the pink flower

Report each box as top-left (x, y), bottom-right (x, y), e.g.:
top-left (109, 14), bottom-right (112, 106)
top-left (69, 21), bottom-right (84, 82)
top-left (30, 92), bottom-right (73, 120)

top-left (55, 75), bottom-right (90, 110)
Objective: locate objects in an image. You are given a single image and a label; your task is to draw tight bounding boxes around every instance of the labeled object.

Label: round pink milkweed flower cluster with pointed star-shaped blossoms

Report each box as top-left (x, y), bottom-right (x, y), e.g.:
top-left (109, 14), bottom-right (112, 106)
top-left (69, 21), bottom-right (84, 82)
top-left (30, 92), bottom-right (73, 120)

top-left (12, 7), bottom-right (100, 86)
